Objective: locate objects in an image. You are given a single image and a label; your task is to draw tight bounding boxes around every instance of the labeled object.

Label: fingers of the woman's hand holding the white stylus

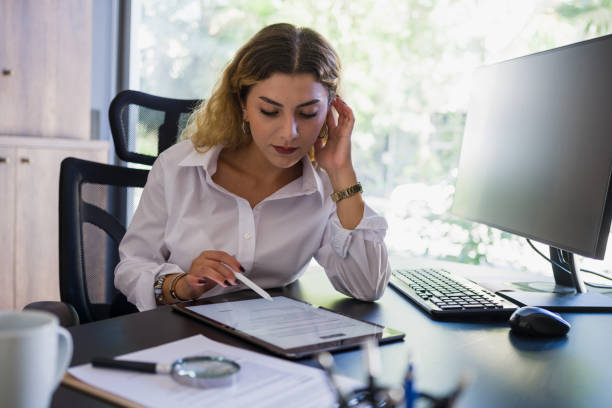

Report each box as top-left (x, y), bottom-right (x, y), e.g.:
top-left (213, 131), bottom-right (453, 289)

top-left (185, 251), bottom-right (244, 287)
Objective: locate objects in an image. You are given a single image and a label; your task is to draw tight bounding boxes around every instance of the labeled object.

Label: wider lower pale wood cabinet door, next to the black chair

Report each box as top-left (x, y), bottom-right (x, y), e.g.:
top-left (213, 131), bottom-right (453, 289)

top-left (15, 148), bottom-right (106, 309)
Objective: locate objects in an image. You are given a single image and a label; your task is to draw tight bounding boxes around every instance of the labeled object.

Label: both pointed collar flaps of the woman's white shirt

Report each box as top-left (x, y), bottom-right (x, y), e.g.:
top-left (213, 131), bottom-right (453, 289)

top-left (179, 145), bottom-right (325, 203)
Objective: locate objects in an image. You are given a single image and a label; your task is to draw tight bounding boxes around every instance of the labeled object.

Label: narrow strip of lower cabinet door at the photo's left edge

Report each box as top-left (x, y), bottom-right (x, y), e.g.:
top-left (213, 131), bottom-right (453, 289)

top-left (0, 147), bottom-right (16, 309)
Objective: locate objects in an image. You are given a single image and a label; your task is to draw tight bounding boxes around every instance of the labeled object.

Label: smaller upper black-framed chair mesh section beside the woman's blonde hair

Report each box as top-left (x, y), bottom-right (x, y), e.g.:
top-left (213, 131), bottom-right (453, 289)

top-left (108, 90), bottom-right (201, 165)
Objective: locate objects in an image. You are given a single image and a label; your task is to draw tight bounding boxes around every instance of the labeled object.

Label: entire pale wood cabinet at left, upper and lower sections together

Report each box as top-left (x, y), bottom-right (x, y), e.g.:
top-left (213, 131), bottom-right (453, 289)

top-left (0, 0), bottom-right (108, 309)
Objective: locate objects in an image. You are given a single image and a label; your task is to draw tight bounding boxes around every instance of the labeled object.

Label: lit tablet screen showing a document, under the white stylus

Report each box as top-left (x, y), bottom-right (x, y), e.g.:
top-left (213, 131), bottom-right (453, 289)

top-left (187, 296), bottom-right (382, 349)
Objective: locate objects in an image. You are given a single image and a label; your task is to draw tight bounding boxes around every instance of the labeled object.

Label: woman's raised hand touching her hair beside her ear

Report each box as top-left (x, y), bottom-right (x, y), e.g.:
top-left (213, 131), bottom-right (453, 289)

top-left (315, 96), bottom-right (355, 177)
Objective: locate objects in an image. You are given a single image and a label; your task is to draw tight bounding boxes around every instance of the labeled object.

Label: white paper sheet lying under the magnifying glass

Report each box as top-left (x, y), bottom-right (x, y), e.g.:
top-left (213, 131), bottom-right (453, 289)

top-left (68, 335), bottom-right (361, 408)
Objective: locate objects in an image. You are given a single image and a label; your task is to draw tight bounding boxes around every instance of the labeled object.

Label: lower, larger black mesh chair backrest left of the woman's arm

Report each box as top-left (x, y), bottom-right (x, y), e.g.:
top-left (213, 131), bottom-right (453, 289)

top-left (59, 157), bottom-right (148, 323)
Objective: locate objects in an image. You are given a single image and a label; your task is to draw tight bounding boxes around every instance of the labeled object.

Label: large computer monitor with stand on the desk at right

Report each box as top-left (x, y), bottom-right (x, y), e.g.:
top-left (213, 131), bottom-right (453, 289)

top-left (452, 35), bottom-right (612, 312)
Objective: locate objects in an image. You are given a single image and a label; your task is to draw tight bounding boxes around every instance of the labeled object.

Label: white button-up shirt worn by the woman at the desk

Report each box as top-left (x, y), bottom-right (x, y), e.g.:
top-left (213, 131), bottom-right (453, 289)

top-left (115, 140), bottom-right (390, 311)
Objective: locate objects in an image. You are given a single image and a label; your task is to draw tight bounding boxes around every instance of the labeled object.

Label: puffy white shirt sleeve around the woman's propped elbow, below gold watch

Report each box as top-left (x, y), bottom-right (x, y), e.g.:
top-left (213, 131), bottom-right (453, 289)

top-left (315, 205), bottom-right (391, 301)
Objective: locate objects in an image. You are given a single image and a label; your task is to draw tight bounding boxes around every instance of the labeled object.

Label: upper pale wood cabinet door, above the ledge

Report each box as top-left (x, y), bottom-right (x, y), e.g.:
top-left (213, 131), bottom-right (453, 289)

top-left (0, 0), bottom-right (91, 139)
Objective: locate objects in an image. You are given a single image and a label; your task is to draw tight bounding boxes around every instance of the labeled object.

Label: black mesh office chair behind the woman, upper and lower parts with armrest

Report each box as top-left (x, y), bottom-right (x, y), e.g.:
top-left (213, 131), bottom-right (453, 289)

top-left (24, 90), bottom-right (200, 327)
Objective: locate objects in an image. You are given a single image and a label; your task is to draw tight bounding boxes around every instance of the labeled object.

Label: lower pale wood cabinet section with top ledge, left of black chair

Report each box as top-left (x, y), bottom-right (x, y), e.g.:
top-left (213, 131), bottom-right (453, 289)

top-left (0, 136), bottom-right (108, 309)
